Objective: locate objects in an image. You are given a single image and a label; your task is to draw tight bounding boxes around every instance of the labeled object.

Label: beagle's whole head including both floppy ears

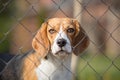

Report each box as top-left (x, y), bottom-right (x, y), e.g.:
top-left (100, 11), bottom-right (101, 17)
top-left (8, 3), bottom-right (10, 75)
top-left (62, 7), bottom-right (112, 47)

top-left (32, 18), bottom-right (89, 56)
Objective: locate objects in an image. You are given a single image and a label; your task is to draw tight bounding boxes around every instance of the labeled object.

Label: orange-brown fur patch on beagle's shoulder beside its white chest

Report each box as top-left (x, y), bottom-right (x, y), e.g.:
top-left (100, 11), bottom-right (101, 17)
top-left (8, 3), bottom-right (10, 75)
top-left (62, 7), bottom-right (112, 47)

top-left (22, 53), bottom-right (40, 80)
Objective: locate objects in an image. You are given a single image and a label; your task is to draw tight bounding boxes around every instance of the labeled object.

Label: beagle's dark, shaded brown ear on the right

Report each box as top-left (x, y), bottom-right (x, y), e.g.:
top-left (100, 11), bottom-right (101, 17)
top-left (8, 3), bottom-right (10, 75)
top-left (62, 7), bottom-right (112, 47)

top-left (73, 20), bottom-right (89, 56)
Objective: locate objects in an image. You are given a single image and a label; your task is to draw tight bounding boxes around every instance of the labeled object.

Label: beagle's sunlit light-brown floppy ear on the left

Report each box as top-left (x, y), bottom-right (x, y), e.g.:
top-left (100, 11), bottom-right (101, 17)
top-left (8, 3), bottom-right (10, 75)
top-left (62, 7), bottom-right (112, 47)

top-left (32, 22), bottom-right (50, 57)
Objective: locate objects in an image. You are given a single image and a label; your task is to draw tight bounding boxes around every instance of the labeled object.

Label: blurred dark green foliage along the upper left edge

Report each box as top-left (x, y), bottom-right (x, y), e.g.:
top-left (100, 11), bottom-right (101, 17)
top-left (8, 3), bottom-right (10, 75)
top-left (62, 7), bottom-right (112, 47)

top-left (0, 0), bottom-right (15, 53)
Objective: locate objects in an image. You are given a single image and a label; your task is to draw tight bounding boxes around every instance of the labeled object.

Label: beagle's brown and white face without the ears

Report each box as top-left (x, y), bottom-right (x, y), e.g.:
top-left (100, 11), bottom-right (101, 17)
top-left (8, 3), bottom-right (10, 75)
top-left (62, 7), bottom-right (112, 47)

top-left (47, 18), bottom-right (79, 56)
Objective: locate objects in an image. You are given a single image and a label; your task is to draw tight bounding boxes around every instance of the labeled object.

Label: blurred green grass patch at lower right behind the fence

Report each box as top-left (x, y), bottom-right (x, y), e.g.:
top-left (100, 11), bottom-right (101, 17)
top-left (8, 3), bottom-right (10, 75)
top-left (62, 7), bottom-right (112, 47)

top-left (76, 54), bottom-right (120, 80)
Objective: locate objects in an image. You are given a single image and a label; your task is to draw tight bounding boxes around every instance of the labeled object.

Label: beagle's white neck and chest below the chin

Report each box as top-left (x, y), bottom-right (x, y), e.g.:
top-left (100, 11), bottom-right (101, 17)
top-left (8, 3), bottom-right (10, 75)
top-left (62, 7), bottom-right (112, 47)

top-left (35, 53), bottom-right (72, 80)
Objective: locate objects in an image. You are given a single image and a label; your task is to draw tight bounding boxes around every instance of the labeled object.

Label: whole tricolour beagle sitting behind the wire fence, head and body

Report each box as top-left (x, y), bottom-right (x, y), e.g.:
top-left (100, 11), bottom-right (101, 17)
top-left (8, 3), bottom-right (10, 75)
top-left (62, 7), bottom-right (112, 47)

top-left (2, 18), bottom-right (89, 80)
